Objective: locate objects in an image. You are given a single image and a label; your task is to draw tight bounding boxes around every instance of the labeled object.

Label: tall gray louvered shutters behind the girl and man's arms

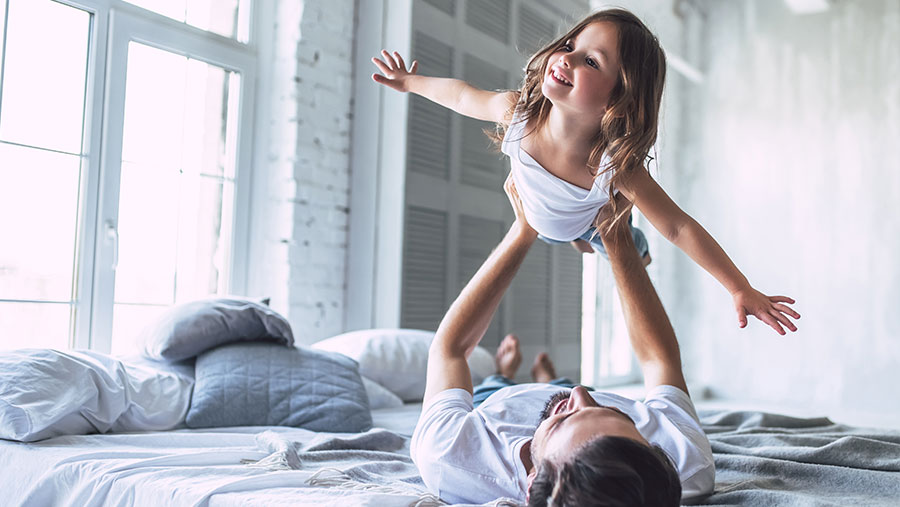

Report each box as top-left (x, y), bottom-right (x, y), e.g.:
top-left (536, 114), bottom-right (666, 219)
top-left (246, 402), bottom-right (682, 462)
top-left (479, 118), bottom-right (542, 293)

top-left (398, 0), bottom-right (587, 381)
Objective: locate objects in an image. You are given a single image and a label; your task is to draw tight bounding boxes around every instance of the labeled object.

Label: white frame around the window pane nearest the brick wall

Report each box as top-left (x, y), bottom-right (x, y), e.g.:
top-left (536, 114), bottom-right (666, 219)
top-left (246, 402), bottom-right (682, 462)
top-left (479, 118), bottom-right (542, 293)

top-left (29, 0), bottom-right (258, 352)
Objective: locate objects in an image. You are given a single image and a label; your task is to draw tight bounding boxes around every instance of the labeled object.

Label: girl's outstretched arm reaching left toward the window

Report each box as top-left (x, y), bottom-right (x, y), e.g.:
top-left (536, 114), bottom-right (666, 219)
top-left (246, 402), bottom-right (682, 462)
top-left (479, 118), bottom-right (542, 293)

top-left (372, 50), bottom-right (519, 123)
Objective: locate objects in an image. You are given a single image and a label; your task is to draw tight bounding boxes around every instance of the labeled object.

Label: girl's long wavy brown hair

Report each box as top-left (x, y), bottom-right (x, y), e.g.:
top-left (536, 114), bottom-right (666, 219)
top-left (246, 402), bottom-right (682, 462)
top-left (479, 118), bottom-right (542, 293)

top-left (486, 9), bottom-right (666, 234)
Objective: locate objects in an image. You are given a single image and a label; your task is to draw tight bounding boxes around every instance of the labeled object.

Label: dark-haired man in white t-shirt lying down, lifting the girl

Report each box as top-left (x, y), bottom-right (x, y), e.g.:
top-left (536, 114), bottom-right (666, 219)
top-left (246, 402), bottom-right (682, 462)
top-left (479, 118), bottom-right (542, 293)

top-left (410, 180), bottom-right (715, 507)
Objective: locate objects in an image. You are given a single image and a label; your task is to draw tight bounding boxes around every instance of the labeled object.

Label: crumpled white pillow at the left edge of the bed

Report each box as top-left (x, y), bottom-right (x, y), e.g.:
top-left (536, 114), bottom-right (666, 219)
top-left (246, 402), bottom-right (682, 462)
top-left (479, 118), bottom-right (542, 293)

top-left (0, 349), bottom-right (194, 442)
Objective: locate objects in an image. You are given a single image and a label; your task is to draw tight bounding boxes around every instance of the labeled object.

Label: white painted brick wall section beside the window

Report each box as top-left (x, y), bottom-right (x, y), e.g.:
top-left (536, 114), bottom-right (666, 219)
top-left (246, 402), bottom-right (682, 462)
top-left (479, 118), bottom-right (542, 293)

top-left (248, 0), bottom-right (355, 343)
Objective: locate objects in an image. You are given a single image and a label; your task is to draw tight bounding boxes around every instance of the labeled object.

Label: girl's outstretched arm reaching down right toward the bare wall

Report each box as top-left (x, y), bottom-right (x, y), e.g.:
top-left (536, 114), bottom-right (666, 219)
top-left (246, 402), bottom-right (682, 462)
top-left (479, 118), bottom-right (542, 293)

top-left (619, 170), bottom-right (800, 335)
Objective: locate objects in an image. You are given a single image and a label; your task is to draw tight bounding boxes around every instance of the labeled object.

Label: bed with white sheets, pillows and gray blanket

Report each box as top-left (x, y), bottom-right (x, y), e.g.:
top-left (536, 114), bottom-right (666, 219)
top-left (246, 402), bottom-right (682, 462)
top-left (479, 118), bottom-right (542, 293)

top-left (0, 300), bottom-right (900, 507)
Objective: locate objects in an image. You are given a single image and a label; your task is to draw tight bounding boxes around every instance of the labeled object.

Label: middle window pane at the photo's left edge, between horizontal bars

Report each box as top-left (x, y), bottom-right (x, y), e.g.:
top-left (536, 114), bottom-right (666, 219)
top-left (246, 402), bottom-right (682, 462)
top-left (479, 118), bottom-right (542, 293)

top-left (0, 143), bottom-right (80, 302)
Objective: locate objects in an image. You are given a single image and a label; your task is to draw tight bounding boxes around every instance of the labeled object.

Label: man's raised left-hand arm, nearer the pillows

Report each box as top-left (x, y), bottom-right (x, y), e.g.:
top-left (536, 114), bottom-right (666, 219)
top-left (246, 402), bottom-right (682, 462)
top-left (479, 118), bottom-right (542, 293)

top-left (424, 178), bottom-right (537, 403)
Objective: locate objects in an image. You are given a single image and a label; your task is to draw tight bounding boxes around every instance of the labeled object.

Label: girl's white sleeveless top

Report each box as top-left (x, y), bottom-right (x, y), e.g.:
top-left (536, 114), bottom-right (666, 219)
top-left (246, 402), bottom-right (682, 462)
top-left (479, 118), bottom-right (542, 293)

top-left (500, 109), bottom-right (611, 241)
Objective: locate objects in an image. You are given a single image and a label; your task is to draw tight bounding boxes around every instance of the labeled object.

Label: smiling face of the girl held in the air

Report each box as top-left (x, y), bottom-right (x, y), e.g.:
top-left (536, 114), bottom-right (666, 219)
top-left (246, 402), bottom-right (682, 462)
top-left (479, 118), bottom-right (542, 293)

top-left (541, 21), bottom-right (619, 113)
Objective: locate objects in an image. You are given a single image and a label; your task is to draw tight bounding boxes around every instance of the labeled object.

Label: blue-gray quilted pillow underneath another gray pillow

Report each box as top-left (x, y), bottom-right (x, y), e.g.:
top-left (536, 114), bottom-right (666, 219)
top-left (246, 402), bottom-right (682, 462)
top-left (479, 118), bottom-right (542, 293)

top-left (185, 343), bottom-right (372, 433)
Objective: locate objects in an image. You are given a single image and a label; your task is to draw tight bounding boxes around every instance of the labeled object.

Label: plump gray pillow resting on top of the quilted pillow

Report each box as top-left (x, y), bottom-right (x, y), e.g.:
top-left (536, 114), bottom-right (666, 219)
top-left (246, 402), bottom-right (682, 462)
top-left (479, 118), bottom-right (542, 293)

top-left (141, 297), bottom-right (294, 361)
